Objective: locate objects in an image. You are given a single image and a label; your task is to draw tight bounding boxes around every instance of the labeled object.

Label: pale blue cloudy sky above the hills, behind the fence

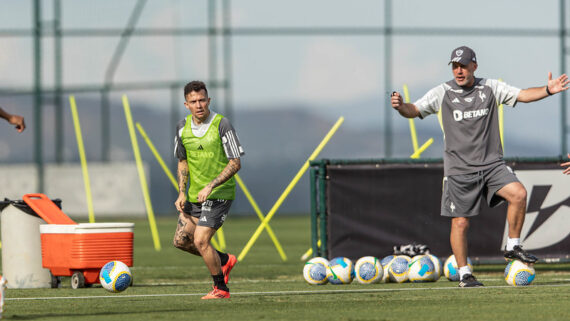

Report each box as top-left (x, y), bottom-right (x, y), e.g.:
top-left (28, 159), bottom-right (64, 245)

top-left (0, 0), bottom-right (570, 156)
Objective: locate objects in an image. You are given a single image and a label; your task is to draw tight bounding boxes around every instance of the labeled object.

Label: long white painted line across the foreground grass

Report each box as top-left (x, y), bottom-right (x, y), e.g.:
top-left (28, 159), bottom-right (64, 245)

top-left (5, 283), bottom-right (570, 301)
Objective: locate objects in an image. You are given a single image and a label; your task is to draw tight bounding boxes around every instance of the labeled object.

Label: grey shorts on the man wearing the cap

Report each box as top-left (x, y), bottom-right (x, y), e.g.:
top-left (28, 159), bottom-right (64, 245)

top-left (441, 164), bottom-right (519, 217)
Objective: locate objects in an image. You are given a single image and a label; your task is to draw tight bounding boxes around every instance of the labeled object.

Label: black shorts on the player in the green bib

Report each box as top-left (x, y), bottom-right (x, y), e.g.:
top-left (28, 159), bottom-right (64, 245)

top-left (184, 199), bottom-right (232, 230)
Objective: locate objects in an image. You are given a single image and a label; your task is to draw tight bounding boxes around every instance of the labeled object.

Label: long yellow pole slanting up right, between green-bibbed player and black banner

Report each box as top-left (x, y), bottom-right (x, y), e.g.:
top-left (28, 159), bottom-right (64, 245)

top-left (238, 116), bottom-right (344, 261)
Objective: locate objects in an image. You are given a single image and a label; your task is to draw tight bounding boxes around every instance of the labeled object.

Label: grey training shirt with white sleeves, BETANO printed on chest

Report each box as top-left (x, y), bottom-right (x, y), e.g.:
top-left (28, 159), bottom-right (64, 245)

top-left (415, 78), bottom-right (521, 176)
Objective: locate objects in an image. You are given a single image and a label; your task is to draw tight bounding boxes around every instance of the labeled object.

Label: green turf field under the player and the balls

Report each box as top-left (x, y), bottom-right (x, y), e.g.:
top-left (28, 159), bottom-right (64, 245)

top-left (3, 216), bottom-right (570, 321)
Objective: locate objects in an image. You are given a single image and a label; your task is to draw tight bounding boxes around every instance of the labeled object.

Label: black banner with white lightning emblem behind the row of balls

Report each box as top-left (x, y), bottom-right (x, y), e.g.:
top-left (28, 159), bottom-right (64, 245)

top-left (326, 162), bottom-right (570, 263)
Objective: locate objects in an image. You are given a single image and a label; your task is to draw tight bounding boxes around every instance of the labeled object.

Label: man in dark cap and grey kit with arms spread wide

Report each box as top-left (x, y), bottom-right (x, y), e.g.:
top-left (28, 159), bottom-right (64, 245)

top-left (391, 46), bottom-right (569, 287)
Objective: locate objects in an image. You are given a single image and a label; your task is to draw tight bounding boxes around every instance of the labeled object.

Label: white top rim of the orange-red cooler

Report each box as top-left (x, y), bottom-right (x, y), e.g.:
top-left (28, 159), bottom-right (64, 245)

top-left (40, 223), bottom-right (135, 234)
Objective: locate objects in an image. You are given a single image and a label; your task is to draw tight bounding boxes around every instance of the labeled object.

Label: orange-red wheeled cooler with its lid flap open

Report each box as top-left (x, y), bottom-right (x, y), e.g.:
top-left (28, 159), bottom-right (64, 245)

top-left (24, 194), bottom-right (134, 289)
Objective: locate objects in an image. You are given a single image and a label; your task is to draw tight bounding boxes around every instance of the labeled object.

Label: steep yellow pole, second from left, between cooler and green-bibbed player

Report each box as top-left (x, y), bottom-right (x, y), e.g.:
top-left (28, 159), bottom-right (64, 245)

top-left (123, 95), bottom-right (160, 251)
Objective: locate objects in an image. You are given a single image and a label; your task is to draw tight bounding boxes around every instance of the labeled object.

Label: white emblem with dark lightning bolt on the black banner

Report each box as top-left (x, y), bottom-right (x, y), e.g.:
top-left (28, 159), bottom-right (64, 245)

top-left (501, 170), bottom-right (570, 250)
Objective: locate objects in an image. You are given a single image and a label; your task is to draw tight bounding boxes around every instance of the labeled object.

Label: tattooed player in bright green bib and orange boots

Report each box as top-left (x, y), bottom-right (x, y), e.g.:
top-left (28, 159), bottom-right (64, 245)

top-left (174, 81), bottom-right (244, 299)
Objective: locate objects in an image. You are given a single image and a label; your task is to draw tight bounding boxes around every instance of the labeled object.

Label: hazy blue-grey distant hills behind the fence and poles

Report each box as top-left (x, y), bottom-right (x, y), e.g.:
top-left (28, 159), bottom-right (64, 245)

top-left (0, 97), bottom-right (560, 214)
